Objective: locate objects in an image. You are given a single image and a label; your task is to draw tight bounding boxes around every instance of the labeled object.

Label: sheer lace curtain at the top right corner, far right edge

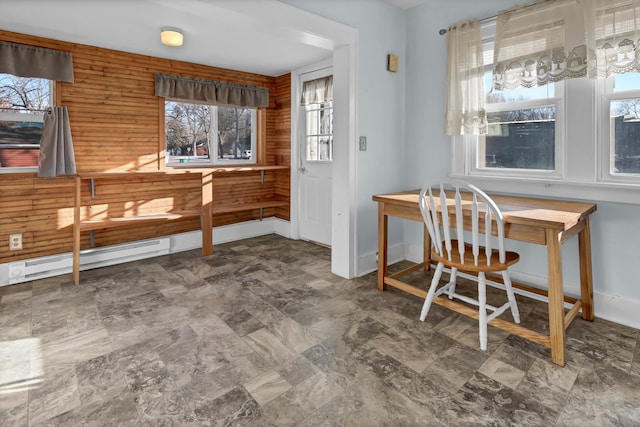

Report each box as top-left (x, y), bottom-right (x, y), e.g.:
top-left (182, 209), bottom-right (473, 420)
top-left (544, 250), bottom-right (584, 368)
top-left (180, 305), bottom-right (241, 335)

top-left (583, 0), bottom-right (640, 78)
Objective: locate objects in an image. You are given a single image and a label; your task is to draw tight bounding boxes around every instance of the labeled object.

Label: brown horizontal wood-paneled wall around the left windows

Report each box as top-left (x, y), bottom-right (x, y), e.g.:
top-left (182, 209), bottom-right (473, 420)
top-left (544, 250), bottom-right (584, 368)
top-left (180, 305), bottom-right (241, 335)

top-left (0, 30), bottom-right (291, 263)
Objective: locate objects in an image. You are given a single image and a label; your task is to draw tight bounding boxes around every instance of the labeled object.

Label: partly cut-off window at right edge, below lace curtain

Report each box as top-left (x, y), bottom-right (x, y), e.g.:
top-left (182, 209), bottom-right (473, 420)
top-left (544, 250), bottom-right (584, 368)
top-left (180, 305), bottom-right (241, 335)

top-left (600, 73), bottom-right (640, 181)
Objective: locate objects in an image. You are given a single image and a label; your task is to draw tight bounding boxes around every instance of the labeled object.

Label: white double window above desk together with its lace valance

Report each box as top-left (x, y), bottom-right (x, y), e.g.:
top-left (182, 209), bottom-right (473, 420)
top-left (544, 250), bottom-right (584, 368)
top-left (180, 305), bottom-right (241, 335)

top-left (452, 0), bottom-right (640, 203)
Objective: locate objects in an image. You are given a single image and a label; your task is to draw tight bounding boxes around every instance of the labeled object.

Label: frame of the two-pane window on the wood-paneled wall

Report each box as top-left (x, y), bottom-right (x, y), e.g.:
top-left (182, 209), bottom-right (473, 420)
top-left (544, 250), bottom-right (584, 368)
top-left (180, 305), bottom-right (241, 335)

top-left (161, 98), bottom-right (264, 168)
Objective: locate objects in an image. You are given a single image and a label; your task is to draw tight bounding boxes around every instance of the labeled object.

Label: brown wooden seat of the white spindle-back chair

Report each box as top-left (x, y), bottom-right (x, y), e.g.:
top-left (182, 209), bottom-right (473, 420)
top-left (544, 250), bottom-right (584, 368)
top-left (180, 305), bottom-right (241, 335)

top-left (431, 240), bottom-right (520, 272)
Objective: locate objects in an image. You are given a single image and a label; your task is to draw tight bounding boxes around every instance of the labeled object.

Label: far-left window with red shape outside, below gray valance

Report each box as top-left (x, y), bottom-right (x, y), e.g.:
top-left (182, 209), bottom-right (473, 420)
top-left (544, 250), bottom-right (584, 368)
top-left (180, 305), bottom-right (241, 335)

top-left (0, 74), bottom-right (53, 172)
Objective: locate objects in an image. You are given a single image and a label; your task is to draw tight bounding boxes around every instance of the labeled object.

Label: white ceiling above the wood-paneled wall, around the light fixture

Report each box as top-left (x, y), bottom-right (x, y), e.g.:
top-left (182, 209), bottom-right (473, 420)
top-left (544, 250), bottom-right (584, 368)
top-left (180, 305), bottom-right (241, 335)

top-left (0, 0), bottom-right (364, 76)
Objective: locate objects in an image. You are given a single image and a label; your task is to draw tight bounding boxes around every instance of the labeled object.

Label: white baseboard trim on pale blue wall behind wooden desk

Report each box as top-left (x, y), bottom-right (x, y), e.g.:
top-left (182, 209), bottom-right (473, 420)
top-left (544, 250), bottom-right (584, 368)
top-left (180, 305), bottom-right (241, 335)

top-left (380, 245), bottom-right (640, 329)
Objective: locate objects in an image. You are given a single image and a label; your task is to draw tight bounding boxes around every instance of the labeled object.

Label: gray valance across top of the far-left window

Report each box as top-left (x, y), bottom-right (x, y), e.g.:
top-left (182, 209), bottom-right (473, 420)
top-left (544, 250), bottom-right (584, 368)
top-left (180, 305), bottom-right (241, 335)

top-left (0, 41), bottom-right (73, 82)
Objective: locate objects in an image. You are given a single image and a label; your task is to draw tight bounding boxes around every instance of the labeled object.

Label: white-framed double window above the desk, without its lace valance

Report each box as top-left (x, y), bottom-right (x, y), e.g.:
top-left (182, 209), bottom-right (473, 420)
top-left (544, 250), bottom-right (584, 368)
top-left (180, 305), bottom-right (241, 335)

top-left (451, 8), bottom-right (640, 204)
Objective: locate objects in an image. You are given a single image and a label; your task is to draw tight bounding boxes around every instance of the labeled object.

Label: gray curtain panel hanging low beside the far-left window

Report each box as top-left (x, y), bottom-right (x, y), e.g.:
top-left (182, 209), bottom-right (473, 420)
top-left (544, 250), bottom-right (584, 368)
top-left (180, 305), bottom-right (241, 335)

top-left (38, 107), bottom-right (76, 177)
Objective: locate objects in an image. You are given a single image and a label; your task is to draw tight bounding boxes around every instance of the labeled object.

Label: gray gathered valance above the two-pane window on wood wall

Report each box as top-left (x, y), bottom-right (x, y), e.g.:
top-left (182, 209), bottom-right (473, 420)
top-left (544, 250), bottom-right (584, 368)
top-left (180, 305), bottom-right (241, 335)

top-left (156, 73), bottom-right (269, 108)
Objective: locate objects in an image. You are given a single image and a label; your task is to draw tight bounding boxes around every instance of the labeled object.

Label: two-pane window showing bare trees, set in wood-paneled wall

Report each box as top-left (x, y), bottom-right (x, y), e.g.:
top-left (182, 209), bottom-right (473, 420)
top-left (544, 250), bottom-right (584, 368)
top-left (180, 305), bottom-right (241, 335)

top-left (165, 100), bottom-right (257, 166)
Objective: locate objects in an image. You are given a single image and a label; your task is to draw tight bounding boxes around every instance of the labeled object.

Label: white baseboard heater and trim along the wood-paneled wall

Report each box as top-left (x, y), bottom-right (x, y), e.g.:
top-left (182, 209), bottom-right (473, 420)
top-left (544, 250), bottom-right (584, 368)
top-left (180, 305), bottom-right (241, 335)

top-left (0, 218), bottom-right (291, 286)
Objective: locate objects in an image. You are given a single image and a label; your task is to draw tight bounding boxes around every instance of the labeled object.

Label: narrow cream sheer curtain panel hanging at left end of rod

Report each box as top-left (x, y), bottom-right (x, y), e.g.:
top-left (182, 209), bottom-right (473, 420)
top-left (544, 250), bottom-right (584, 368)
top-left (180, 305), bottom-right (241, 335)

top-left (445, 19), bottom-right (487, 135)
